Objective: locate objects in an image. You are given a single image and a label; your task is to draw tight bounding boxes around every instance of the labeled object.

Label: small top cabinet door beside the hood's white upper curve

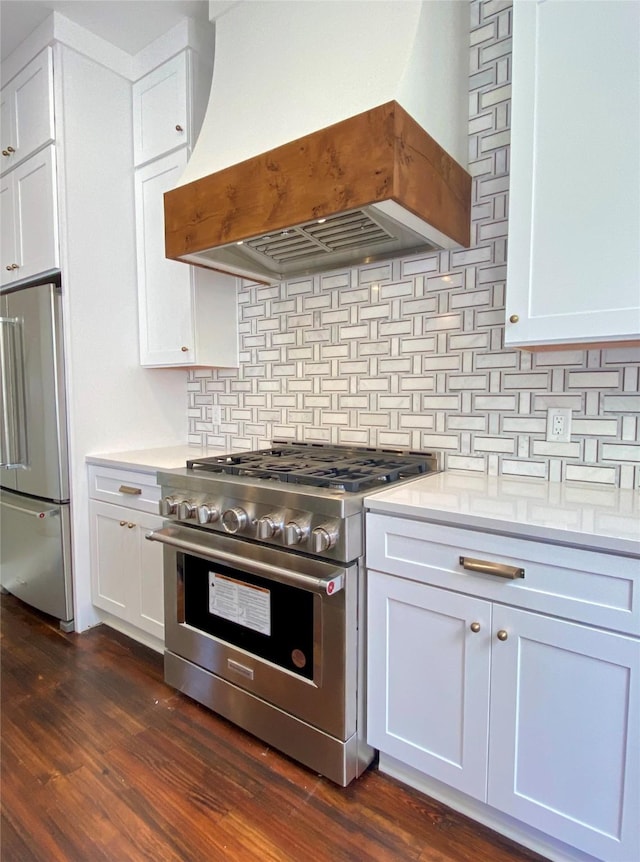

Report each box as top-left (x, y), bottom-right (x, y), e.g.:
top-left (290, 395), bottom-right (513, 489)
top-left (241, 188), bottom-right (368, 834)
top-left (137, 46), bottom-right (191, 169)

top-left (133, 51), bottom-right (191, 166)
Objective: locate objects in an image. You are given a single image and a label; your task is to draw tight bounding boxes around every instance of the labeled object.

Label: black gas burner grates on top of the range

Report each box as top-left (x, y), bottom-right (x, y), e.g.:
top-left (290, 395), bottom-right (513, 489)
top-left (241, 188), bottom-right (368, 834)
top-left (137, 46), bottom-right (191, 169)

top-left (187, 443), bottom-right (437, 493)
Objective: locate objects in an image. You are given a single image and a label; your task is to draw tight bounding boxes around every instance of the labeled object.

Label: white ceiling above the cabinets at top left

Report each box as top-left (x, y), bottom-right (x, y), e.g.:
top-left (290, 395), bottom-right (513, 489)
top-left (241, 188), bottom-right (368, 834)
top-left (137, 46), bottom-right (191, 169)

top-left (0, 0), bottom-right (209, 59)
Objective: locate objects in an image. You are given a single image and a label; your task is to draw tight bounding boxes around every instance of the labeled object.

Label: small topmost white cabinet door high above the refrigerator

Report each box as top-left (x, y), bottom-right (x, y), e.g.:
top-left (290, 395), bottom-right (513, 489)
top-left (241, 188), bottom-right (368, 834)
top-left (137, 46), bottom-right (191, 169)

top-left (0, 48), bottom-right (55, 173)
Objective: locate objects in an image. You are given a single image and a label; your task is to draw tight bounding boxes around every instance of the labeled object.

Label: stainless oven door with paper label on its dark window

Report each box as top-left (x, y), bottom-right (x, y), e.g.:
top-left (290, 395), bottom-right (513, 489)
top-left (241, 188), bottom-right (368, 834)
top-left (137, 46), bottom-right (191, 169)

top-left (148, 523), bottom-right (359, 740)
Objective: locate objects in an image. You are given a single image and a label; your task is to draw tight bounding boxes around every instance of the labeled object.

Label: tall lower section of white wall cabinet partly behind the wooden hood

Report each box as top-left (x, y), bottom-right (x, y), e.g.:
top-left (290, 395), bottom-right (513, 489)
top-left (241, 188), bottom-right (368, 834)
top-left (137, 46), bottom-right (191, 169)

top-left (135, 147), bottom-right (238, 368)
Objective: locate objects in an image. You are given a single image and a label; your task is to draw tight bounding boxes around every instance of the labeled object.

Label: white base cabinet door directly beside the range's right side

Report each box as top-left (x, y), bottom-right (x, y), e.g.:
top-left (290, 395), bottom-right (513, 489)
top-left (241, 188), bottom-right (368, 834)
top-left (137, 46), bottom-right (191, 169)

top-left (367, 571), bottom-right (491, 800)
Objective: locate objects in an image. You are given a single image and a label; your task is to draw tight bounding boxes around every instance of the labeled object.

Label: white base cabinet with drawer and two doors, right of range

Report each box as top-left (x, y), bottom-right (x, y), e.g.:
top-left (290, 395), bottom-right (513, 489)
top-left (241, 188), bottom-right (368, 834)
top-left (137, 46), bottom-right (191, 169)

top-left (367, 515), bottom-right (640, 862)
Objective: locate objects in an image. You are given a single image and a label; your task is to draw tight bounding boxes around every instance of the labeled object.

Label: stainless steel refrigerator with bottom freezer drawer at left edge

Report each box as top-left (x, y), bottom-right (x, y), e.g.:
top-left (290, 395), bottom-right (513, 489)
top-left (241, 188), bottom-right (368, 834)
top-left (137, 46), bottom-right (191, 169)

top-left (0, 273), bottom-right (73, 631)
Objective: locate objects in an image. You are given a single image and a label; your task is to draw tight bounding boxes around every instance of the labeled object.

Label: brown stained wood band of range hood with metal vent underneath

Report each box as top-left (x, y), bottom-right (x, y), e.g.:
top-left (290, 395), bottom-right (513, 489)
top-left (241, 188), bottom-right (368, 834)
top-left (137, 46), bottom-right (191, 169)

top-left (164, 101), bottom-right (471, 283)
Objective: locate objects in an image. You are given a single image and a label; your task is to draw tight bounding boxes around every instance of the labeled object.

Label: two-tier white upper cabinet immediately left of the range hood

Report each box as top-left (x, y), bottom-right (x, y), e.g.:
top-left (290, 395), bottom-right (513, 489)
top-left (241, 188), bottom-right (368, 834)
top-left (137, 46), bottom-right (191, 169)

top-left (133, 49), bottom-right (238, 368)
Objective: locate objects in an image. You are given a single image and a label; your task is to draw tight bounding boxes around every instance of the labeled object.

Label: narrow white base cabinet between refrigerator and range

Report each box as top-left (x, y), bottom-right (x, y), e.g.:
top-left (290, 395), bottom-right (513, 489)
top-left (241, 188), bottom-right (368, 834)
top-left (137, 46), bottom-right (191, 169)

top-left (89, 467), bottom-right (164, 646)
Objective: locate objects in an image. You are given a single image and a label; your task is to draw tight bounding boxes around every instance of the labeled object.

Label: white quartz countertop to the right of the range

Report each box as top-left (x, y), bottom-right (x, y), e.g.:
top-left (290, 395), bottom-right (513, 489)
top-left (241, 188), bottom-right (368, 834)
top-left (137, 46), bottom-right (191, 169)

top-left (365, 471), bottom-right (640, 556)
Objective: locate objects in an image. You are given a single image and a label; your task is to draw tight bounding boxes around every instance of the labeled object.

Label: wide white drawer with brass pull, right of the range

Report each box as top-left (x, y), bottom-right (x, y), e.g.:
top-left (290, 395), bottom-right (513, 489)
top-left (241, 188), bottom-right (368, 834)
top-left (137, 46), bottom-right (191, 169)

top-left (367, 514), bottom-right (640, 634)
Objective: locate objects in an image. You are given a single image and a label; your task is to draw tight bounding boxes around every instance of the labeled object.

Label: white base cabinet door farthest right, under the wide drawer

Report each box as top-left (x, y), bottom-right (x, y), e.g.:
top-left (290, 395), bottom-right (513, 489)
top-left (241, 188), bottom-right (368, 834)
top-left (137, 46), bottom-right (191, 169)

top-left (488, 606), bottom-right (640, 862)
